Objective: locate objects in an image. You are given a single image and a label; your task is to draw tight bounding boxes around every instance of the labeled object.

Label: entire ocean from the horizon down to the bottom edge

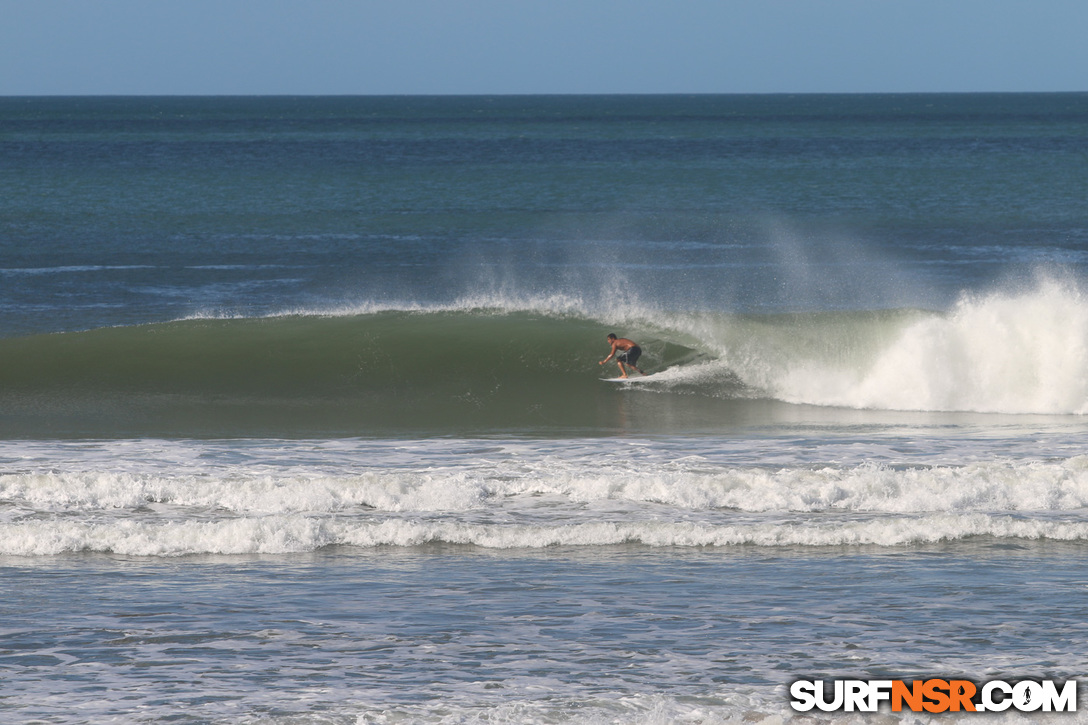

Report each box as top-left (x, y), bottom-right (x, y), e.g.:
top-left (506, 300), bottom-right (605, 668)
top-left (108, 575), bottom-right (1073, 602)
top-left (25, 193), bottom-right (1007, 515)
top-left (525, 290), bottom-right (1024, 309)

top-left (0, 94), bottom-right (1088, 725)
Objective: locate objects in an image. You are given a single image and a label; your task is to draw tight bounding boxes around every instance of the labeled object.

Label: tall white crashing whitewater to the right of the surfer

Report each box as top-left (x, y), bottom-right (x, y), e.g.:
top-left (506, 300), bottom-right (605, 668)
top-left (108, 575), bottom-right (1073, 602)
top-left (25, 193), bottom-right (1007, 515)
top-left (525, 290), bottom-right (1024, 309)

top-left (730, 280), bottom-right (1088, 415)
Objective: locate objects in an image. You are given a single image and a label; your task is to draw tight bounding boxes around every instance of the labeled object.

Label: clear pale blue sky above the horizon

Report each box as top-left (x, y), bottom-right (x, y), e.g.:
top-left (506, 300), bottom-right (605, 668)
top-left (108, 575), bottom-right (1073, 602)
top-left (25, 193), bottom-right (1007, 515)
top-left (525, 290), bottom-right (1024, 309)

top-left (0, 0), bottom-right (1088, 96)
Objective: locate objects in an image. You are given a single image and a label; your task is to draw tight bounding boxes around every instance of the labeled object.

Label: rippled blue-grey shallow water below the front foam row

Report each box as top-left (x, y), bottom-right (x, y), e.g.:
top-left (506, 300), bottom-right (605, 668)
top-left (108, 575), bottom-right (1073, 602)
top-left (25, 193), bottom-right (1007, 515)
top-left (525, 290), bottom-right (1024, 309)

top-left (4, 540), bottom-right (1084, 723)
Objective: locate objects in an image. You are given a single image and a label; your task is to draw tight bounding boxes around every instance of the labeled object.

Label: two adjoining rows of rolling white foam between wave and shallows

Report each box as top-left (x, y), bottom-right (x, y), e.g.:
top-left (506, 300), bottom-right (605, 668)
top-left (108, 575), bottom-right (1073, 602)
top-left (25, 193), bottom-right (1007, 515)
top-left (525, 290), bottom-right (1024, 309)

top-left (6, 445), bottom-right (1088, 556)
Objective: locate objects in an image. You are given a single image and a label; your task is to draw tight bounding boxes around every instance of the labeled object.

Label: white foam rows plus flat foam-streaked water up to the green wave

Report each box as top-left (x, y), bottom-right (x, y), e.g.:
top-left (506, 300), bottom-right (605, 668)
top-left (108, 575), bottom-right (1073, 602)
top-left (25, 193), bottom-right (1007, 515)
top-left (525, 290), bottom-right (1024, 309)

top-left (0, 431), bottom-right (1088, 556)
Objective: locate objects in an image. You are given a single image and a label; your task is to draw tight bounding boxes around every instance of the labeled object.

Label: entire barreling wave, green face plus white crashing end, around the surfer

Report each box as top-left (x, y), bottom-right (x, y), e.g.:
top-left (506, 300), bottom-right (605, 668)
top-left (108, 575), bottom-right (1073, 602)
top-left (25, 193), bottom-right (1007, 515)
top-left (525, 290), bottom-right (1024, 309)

top-left (0, 276), bottom-right (1088, 437)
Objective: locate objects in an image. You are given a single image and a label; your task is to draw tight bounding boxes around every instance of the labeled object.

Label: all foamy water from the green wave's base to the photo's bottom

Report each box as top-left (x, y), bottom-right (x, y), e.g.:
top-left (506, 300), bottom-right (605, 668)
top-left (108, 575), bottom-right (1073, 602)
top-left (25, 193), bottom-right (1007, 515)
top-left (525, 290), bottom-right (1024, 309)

top-left (6, 428), bottom-right (1088, 723)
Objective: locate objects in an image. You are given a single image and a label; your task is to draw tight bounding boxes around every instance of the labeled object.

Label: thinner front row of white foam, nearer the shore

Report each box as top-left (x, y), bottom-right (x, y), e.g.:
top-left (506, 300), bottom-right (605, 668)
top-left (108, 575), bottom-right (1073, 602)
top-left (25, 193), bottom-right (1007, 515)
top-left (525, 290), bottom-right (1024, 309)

top-left (6, 505), bottom-right (1088, 556)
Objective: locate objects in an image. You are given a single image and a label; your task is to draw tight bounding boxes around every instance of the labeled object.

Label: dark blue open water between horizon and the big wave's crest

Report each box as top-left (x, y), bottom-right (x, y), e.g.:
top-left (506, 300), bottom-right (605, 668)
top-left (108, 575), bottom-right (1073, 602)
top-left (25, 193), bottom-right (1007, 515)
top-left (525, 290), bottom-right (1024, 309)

top-left (0, 94), bottom-right (1088, 334)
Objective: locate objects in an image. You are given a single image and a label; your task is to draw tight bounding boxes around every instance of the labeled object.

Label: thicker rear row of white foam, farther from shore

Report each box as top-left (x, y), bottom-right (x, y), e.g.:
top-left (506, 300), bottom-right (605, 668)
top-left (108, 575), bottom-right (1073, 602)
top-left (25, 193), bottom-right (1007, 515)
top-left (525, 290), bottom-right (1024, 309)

top-left (8, 456), bottom-right (1088, 516)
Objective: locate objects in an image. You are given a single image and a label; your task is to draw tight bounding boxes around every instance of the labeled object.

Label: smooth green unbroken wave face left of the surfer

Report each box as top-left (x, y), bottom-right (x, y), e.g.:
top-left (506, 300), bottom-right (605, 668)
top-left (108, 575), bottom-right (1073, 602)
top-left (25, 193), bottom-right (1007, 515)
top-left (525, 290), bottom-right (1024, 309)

top-left (0, 311), bottom-right (718, 438)
